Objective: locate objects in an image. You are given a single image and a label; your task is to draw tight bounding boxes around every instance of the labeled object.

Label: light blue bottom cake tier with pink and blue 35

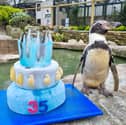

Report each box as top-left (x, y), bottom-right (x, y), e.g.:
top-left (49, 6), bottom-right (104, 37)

top-left (7, 81), bottom-right (66, 115)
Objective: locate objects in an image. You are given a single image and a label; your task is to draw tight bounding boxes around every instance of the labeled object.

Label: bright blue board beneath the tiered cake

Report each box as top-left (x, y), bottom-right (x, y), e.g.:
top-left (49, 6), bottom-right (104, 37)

top-left (0, 84), bottom-right (103, 125)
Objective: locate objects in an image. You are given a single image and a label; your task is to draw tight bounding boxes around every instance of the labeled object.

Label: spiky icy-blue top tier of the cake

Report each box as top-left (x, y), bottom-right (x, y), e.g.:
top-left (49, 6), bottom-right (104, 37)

top-left (18, 29), bottom-right (53, 68)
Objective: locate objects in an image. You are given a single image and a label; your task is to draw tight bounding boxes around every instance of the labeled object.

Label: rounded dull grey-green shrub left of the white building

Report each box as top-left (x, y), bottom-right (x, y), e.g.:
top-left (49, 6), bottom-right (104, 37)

top-left (9, 12), bottom-right (35, 29)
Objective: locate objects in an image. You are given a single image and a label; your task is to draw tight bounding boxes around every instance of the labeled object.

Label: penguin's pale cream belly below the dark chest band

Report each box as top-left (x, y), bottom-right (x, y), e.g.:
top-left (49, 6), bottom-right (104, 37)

top-left (82, 48), bottom-right (110, 87)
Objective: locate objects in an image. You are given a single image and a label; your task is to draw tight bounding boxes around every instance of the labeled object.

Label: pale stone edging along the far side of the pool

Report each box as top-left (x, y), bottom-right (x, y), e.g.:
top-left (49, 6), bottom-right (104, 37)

top-left (0, 41), bottom-right (126, 63)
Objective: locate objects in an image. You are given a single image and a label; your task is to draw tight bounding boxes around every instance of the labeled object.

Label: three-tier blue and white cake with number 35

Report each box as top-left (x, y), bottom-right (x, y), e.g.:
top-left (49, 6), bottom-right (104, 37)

top-left (7, 29), bottom-right (66, 114)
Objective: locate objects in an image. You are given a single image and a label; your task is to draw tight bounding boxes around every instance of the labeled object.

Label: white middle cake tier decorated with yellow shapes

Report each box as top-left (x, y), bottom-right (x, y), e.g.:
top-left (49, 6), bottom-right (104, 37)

top-left (10, 60), bottom-right (62, 89)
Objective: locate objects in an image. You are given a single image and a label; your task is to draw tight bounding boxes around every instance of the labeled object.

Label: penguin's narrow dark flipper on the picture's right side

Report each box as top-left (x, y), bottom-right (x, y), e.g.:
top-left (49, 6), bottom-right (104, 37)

top-left (110, 56), bottom-right (119, 91)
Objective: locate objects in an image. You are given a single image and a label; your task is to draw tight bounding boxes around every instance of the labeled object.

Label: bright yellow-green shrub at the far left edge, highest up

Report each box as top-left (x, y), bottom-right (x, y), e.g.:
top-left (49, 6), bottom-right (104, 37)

top-left (0, 6), bottom-right (22, 25)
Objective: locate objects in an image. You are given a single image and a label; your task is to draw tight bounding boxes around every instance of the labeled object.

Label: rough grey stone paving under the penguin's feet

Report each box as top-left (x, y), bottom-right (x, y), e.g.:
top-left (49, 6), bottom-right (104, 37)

top-left (59, 64), bottom-right (126, 125)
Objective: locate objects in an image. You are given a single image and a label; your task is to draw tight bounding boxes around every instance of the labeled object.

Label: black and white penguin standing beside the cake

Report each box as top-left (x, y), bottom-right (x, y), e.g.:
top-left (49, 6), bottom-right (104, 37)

top-left (73, 20), bottom-right (119, 97)
